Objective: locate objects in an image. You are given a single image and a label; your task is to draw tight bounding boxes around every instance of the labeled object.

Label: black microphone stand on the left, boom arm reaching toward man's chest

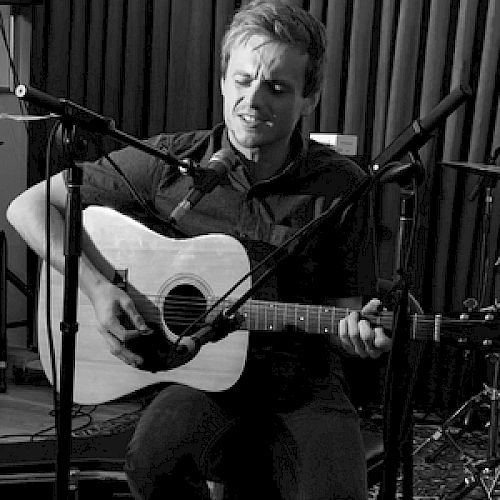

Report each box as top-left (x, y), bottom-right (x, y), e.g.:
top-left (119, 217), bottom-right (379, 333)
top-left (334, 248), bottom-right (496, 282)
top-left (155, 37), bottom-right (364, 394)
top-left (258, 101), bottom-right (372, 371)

top-left (15, 85), bottom-right (191, 500)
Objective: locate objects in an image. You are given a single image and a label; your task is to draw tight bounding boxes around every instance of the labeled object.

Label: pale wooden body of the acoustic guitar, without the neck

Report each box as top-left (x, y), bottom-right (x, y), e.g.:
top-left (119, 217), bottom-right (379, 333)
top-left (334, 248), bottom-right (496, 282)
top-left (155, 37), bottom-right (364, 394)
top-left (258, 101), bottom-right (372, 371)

top-left (38, 207), bottom-right (250, 404)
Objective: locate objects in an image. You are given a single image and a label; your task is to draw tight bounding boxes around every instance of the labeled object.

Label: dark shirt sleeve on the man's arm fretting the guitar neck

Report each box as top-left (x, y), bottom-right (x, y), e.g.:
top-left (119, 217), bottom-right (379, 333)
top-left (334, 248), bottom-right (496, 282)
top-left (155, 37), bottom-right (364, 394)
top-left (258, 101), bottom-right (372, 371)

top-left (290, 147), bottom-right (377, 303)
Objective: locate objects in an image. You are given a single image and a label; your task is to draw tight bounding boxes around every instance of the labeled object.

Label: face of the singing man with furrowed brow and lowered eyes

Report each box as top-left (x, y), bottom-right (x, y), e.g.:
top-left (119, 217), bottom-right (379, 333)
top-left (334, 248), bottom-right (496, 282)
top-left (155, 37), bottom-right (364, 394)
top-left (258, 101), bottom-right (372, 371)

top-left (221, 35), bottom-right (317, 153)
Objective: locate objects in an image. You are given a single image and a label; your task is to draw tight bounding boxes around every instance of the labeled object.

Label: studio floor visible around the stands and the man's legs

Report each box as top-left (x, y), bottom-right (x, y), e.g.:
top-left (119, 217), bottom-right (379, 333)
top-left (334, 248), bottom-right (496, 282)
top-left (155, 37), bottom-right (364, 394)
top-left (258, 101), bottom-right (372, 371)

top-left (6, 349), bottom-right (497, 500)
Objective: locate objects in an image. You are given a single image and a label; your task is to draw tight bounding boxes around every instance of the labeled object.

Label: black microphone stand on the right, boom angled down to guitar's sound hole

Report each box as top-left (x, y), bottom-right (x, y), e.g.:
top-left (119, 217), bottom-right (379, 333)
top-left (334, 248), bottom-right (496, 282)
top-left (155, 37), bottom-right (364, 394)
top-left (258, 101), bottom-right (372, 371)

top-left (181, 152), bottom-right (423, 500)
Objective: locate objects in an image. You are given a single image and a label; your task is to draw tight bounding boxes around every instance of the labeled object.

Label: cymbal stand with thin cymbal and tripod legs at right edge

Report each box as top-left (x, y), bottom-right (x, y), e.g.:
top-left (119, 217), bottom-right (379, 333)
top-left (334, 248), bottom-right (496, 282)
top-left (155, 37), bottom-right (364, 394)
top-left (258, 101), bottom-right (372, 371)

top-left (414, 153), bottom-right (500, 500)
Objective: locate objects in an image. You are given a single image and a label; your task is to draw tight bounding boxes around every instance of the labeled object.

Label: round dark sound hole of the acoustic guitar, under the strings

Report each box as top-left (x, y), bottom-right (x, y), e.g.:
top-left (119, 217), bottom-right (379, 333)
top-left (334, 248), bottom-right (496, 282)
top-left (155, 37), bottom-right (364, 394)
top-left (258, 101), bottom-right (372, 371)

top-left (163, 284), bottom-right (207, 335)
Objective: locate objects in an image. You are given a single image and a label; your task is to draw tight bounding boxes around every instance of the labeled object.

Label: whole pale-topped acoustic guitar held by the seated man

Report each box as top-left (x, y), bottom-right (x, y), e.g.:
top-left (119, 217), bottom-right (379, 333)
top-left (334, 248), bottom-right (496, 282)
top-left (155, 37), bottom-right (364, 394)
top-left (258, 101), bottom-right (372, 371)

top-left (38, 207), bottom-right (498, 404)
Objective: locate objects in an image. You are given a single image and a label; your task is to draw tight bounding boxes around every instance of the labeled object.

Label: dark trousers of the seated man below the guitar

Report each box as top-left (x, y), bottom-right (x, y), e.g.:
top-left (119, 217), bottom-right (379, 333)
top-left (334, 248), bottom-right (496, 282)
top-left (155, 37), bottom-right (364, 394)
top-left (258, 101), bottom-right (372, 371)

top-left (126, 385), bottom-right (367, 500)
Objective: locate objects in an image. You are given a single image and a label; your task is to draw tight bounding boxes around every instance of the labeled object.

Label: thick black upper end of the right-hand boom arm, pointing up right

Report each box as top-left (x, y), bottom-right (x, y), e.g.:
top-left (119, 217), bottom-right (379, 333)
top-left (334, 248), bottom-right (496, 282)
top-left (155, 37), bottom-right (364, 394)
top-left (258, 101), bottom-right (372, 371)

top-left (372, 85), bottom-right (472, 170)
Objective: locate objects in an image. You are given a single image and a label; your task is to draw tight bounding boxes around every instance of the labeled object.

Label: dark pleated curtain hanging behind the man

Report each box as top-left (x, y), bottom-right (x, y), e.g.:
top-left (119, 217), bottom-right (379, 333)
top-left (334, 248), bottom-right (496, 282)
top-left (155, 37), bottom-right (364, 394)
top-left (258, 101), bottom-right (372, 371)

top-left (2, 0), bottom-right (500, 411)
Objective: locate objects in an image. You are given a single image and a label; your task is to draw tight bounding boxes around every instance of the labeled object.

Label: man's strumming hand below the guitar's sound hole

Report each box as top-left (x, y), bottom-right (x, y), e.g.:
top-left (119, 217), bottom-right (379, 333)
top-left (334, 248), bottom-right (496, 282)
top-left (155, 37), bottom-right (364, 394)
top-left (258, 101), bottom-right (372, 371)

top-left (89, 281), bottom-right (152, 367)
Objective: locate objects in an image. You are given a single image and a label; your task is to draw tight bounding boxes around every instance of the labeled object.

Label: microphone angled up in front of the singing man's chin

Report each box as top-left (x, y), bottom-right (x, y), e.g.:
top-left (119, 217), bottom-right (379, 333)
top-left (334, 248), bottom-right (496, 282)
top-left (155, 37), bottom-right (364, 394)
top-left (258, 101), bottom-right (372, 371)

top-left (170, 148), bottom-right (236, 223)
